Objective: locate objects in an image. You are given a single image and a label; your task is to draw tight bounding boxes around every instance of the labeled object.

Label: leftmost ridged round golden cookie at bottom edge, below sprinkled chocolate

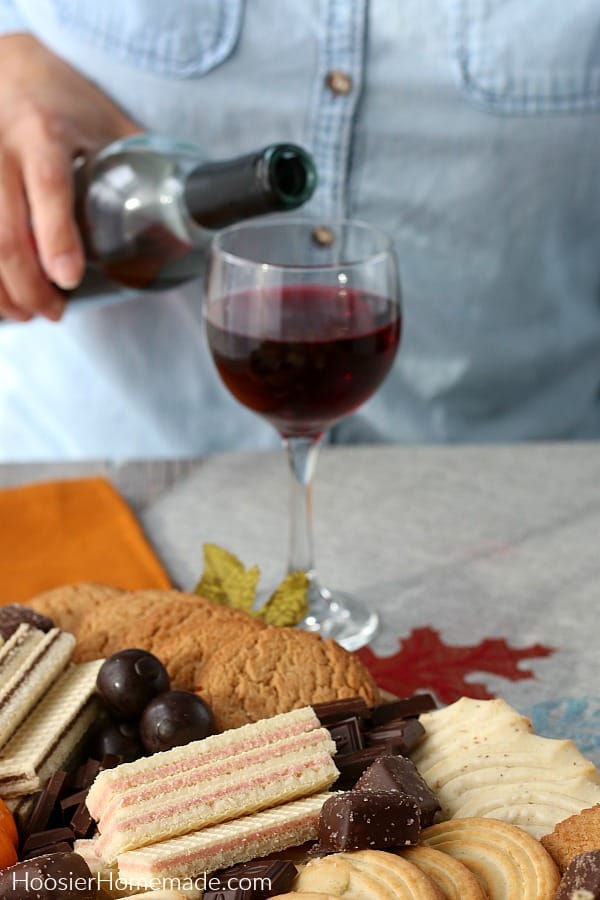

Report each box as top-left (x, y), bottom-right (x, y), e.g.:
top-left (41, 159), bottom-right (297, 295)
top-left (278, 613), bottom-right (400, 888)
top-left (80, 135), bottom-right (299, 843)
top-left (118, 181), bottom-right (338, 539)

top-left (292, 850), bottom-right (444, 900)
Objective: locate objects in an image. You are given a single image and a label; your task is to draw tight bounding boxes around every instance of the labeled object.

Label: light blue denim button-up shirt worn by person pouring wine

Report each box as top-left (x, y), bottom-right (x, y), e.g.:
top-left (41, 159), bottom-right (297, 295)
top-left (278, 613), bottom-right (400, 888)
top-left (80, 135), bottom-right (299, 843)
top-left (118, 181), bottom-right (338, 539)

top-left (0, 0), bottom-right (600, 459)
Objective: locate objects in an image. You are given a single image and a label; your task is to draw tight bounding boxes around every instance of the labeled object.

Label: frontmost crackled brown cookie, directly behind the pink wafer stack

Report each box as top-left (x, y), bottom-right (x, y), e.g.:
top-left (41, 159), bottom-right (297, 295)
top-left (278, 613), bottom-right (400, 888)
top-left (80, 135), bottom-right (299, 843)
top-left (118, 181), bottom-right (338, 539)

top-left (194, 626), bottom-right (379, 729)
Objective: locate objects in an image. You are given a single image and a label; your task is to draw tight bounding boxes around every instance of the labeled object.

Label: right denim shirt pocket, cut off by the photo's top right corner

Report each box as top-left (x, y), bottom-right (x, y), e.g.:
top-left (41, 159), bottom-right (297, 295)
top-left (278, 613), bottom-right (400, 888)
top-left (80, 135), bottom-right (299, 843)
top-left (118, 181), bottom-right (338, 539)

top-left (449, 0), bottom-right (600, 115)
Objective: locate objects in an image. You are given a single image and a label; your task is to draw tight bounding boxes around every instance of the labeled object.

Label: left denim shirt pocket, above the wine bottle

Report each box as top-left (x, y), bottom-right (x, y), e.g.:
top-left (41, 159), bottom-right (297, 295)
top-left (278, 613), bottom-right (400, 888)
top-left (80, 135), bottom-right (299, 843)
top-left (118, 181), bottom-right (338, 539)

top-left (51, 0), bottom-right (245, 78)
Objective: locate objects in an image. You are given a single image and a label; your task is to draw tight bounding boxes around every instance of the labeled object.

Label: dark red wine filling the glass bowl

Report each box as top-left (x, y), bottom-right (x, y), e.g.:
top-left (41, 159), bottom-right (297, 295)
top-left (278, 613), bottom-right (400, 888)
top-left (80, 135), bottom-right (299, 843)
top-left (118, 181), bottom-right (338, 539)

top-left (207, 284), bottom-right (401, 437)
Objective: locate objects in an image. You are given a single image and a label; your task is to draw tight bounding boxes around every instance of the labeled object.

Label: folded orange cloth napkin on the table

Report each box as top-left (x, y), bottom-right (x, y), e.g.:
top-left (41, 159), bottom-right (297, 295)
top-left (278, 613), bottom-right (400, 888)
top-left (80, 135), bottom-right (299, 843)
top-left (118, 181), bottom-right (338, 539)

top-left (0, 478), bottom-right (171, 605)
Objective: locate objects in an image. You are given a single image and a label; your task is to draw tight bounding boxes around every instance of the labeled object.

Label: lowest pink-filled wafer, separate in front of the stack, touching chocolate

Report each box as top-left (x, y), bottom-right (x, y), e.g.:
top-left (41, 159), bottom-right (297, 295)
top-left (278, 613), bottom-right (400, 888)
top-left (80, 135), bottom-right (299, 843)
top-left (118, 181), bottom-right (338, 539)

top-left (117, 792), bottom-right (331, 888)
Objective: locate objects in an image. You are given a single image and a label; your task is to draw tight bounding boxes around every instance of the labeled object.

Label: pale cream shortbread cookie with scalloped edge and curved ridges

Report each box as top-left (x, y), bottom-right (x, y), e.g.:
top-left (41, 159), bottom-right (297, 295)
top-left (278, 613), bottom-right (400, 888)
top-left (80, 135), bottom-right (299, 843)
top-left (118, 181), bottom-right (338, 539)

top-left (413, 697), bottom-right (600, 838)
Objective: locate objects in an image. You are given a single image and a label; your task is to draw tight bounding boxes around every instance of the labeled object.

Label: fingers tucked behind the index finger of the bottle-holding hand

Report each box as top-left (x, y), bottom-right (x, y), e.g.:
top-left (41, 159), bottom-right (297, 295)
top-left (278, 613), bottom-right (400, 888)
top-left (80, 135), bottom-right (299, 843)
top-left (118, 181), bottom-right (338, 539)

top-left (0, 154), bottom-right (64, 321)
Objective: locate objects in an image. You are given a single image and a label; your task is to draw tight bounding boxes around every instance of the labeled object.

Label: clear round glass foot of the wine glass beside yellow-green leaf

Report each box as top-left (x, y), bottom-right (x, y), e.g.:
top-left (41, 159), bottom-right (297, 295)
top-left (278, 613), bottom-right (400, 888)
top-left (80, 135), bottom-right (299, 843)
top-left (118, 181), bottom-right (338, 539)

top-left (298, 582), bottom-right (379, 650)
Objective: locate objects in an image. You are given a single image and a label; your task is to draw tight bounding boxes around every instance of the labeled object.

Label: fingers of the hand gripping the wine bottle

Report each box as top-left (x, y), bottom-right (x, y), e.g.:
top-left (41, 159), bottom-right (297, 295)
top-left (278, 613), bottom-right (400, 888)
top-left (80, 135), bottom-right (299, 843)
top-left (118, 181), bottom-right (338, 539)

top-left (0, 103), bottom-right (85, 320)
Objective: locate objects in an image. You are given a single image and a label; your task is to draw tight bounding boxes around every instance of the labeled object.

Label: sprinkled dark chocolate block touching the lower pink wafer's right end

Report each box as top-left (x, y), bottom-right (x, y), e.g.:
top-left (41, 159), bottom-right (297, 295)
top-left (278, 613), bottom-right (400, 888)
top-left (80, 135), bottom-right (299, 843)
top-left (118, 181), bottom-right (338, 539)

top-left (319, 790), bottom-right (421, 852)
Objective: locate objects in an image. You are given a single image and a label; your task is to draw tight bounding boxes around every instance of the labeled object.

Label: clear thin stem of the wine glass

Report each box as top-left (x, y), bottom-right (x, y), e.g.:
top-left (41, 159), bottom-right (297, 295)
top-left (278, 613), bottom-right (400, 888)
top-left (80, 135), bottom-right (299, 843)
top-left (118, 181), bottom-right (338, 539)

top-left (284, 436), bottom-right (321, 582)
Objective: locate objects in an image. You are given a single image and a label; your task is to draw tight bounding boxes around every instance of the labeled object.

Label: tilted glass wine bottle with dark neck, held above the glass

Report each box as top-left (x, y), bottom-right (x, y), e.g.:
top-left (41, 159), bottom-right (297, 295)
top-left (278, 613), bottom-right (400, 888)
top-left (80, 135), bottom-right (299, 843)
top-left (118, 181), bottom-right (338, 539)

top-left (69, 134), bottom-right (316, 299)
